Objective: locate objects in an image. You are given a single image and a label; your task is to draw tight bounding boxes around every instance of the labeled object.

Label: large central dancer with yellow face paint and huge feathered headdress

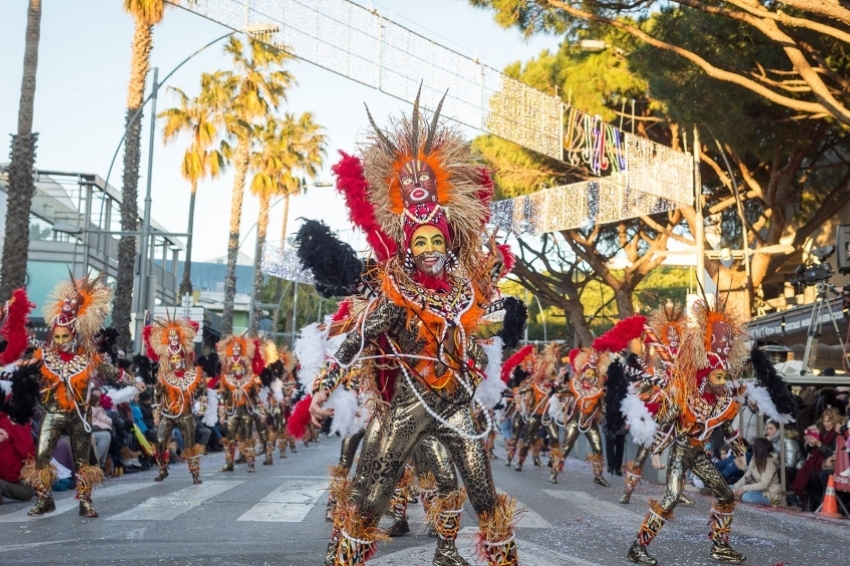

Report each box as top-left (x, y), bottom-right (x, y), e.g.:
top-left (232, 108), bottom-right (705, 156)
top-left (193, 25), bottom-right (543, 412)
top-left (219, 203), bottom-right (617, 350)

top-left (304, 91), bottom-right (517, 566)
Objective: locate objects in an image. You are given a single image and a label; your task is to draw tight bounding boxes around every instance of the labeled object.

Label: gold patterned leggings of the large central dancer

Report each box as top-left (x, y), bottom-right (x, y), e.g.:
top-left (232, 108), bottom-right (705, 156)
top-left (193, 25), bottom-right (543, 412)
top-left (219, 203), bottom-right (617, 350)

top-left (352, 381), bottom-right (496, 527)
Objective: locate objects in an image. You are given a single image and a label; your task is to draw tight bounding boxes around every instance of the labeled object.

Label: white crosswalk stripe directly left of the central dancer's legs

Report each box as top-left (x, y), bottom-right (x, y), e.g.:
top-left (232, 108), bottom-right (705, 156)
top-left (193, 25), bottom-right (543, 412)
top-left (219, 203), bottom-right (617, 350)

top-left (237, 479), bottom-right (328, 523)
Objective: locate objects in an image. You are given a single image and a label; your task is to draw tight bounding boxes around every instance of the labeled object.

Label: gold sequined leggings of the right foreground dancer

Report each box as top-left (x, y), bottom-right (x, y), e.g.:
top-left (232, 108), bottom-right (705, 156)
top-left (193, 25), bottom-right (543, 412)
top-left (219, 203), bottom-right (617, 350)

top-left (661, 442), bottom-right (735, 512)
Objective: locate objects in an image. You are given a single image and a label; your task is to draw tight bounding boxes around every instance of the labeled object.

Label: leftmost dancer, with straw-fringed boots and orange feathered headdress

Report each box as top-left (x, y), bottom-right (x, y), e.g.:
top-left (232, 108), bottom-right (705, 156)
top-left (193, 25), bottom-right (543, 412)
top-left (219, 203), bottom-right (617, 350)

top-left (21, 277), bottom-right (115, 518)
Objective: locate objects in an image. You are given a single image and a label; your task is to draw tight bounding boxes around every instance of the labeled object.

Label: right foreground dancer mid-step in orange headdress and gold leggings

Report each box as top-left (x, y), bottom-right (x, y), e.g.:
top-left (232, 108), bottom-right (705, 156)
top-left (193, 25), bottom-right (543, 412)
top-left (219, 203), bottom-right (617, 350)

top-left (628, 296), bottom-right (747, 565)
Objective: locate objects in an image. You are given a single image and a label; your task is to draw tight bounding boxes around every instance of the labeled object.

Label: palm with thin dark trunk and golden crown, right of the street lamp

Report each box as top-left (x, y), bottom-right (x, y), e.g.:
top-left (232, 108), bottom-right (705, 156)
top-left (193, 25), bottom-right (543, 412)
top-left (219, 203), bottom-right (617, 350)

top-left (159, 71), bottom-right (230, 297)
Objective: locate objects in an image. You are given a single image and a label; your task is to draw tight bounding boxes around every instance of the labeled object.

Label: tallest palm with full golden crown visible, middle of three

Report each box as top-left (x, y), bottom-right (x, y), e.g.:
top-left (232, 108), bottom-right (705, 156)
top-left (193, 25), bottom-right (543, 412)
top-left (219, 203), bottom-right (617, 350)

top-left (221, 37), bottom-right (295, 334)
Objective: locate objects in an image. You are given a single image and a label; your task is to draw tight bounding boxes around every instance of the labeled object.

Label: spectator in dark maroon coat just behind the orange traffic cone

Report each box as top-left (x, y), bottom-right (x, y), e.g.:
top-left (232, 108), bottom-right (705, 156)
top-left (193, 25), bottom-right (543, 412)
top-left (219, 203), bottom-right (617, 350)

top-left (791, 407), bottom-right (842, 511)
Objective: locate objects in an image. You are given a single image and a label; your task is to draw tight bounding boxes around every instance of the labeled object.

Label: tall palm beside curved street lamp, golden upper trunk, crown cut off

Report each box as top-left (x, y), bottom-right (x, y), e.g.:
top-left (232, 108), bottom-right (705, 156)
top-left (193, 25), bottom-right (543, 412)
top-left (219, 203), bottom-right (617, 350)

top-left (112, 0), bottom-right (165, 350)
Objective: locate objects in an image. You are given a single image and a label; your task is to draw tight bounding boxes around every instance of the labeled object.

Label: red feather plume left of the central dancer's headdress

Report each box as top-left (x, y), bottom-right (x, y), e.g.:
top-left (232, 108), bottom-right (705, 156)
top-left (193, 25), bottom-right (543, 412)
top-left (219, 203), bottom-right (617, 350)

top-left (331, 151), bottom-right (397, 261)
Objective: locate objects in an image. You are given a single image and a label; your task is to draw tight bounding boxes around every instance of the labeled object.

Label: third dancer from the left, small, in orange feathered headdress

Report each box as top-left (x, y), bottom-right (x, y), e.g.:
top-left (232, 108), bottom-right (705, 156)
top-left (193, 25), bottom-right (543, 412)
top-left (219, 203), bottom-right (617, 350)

top-left (216, 335), bottom-right (267, 472)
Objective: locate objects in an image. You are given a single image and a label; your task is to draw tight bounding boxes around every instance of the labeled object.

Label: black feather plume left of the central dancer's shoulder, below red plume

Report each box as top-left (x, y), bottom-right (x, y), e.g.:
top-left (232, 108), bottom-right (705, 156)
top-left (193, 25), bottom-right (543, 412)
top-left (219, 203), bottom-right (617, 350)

top-left (295, 220), bottom-right (363, 298)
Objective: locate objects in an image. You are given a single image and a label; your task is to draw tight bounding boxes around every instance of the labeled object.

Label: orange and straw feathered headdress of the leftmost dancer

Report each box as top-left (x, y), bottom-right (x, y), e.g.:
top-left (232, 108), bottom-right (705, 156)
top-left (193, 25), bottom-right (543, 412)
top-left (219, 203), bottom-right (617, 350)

top-left (43, 275), bottom-right (112, 350)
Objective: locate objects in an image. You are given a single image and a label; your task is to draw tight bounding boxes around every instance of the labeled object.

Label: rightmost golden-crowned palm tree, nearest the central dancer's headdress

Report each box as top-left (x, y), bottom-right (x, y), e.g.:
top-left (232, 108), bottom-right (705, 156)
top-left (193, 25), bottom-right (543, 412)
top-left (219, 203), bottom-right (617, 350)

top-left (249, 112), bottom-right (327, 334)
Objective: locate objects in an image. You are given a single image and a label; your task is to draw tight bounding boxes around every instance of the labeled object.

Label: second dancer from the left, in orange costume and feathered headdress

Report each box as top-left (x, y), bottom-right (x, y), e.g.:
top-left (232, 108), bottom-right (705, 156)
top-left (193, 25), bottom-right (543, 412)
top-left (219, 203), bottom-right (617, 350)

top-left (143, 316), bottom-right (207, 485)
